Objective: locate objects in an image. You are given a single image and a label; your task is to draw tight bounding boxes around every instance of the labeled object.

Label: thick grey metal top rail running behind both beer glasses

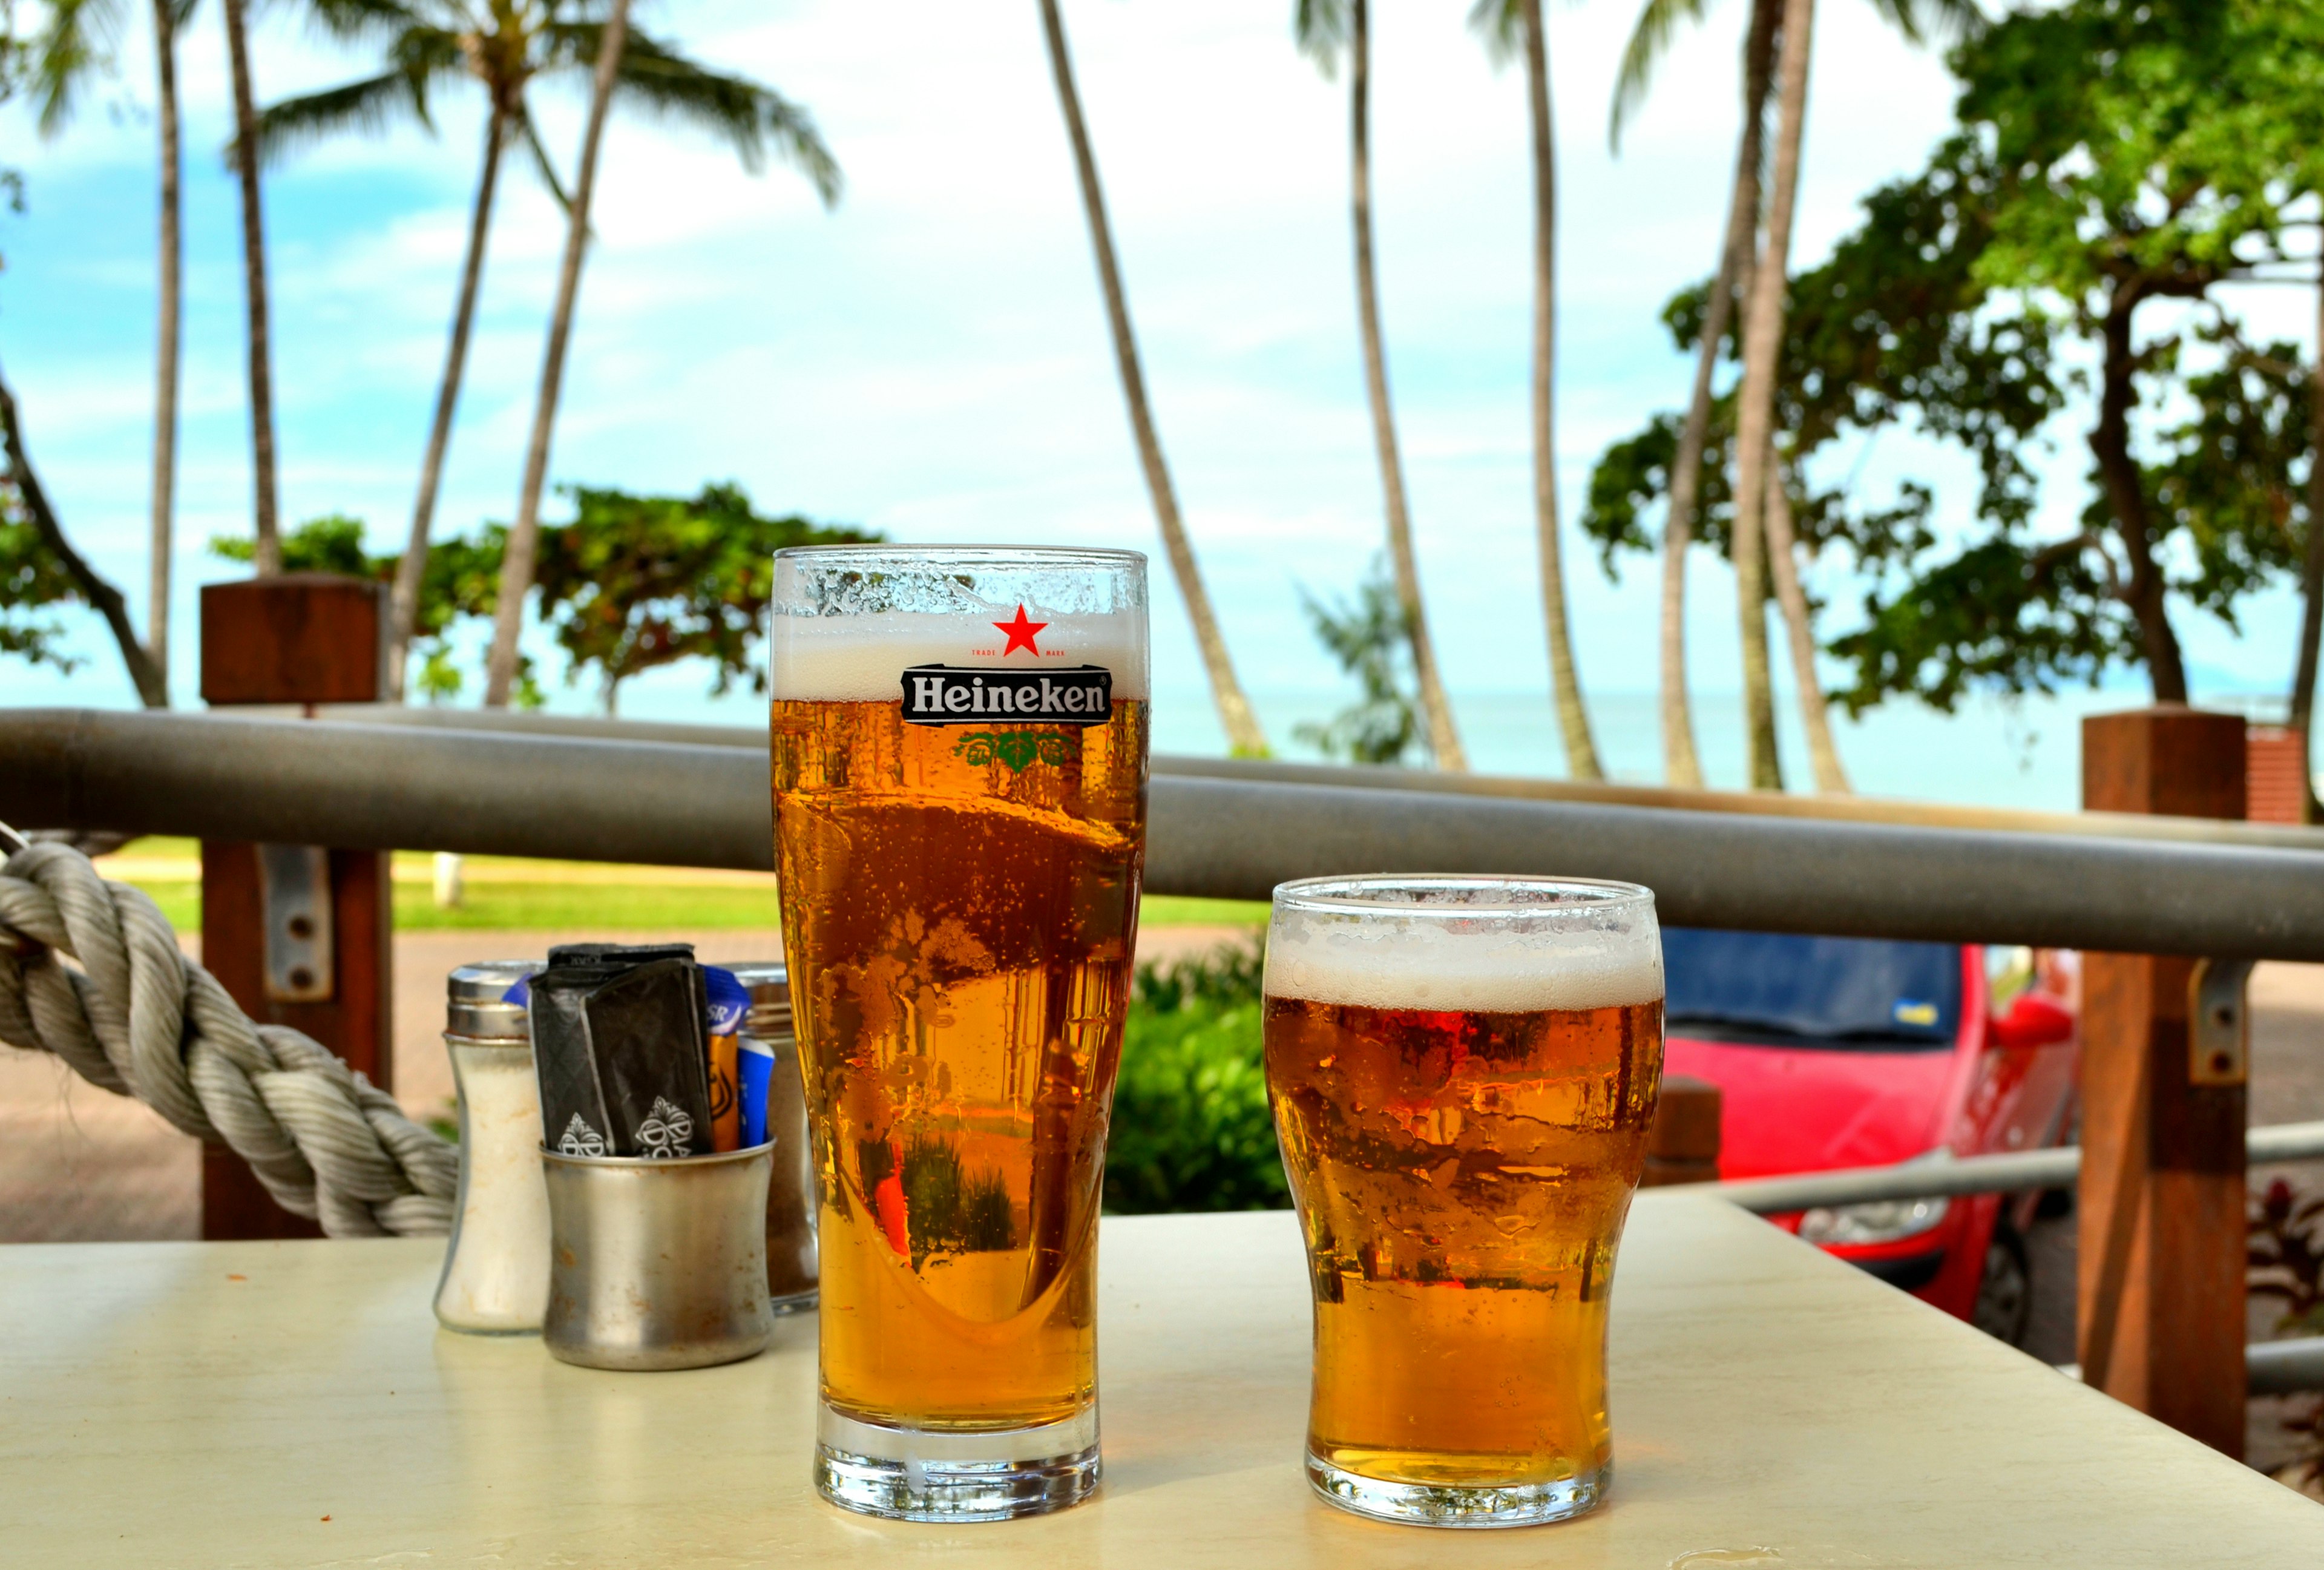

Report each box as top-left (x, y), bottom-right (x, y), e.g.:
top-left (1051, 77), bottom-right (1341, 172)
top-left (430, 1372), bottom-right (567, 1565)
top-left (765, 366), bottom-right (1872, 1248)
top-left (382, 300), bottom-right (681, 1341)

top-left (0, 708), bottom-right (2324, 962)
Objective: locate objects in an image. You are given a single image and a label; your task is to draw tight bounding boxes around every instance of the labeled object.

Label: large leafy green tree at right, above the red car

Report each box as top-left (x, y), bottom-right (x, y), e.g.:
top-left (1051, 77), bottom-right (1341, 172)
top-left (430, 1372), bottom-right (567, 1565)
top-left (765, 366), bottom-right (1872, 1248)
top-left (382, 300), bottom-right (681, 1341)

top-left (1585, 0), bottom-right (2324, 738)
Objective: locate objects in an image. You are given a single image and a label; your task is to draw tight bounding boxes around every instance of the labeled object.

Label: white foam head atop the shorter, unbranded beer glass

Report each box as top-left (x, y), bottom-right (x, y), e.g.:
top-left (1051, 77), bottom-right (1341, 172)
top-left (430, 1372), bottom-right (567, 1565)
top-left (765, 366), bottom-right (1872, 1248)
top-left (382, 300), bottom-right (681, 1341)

top-left (1264, 878), bottom-right (1662, 1013)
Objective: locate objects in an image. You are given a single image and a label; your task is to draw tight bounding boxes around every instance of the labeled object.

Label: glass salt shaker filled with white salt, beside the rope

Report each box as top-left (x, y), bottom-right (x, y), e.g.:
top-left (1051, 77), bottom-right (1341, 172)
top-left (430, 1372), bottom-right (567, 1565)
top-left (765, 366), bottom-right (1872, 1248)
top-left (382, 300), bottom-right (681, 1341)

top-left (435, 959), bottom-right (548, 1335)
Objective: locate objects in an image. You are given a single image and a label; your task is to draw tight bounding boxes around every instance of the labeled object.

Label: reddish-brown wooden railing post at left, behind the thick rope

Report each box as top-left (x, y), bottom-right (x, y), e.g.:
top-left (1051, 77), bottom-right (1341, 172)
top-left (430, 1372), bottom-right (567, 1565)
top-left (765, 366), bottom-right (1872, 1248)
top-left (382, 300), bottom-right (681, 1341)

top-left (202, 574), bottom-right (395, 1238)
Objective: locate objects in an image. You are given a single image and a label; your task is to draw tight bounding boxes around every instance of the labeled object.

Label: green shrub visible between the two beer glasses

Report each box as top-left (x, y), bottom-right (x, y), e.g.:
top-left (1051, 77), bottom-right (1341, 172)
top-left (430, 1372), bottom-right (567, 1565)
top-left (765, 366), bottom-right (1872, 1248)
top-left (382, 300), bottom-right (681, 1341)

top-left (1106, 945), bottom-right (1290, 1215)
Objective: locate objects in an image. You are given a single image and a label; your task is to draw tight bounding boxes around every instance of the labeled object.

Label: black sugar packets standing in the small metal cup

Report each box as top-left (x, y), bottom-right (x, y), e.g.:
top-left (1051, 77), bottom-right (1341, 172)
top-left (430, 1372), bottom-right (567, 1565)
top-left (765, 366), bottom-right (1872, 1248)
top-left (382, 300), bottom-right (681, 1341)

top-left (528, 943), bottom-right (711, 1157)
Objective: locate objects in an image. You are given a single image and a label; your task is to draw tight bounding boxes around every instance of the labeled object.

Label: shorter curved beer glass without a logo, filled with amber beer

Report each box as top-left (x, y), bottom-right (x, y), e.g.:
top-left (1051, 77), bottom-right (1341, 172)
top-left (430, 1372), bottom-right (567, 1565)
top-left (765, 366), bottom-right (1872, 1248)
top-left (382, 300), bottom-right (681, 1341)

top-left (1267, 878), bottom-right (1662, 1526)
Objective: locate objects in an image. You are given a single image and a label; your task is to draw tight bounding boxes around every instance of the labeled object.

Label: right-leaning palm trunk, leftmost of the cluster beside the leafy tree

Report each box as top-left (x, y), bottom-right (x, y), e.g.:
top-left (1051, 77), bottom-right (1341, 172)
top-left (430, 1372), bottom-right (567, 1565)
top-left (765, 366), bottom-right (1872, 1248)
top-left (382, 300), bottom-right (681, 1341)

top-left (1662, 0), bottom-right (1780, 790)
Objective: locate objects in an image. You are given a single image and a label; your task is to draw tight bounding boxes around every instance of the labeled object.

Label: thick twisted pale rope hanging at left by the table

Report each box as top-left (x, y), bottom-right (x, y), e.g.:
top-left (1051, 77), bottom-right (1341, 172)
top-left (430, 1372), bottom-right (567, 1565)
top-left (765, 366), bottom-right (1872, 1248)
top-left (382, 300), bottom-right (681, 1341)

top-left (0, 843), bottom-right (460, 1238)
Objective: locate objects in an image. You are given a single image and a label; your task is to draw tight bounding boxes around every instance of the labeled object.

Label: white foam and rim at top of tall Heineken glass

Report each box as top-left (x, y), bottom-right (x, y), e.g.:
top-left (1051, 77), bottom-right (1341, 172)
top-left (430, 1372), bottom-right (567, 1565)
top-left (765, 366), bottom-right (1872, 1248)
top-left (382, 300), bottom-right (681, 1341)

top-left (767, 546), bottom-right (1148, 704)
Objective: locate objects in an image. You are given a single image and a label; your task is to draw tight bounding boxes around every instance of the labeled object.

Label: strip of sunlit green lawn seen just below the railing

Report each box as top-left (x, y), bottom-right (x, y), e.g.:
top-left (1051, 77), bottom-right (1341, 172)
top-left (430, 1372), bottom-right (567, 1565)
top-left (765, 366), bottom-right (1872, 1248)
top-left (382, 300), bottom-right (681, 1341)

top-left (116, 882), bottom-right (1267, 931)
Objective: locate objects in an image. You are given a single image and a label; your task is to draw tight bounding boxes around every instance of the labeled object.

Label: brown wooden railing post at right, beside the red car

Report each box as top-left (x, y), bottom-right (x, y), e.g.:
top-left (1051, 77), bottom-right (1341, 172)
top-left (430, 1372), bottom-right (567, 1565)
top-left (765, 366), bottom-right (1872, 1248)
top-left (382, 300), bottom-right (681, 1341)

top-left (2075, 706), bottom-right (2245, 1456)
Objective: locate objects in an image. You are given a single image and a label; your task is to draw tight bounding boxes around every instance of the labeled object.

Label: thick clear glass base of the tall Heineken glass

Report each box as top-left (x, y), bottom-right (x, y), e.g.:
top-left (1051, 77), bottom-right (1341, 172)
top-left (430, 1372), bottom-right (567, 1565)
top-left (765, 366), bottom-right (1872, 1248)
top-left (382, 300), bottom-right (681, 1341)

top-left (816, 1403), bottom-right (1099, 1521)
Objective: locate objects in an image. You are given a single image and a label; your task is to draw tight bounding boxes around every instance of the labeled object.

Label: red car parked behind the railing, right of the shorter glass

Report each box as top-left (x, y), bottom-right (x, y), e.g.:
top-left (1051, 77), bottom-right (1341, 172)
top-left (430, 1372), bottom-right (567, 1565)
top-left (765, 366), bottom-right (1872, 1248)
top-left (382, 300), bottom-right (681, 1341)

top-left (1662, 929), bottom-right (2080, 1342)
